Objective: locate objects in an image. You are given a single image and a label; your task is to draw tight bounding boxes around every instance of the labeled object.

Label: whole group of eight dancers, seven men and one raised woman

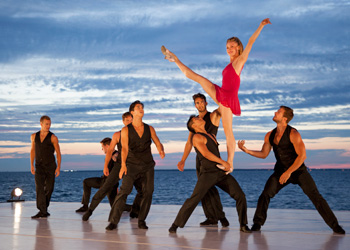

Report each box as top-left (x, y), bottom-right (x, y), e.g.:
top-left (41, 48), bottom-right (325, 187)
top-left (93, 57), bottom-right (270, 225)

top-left (30, 18), bottom-right (345, 234)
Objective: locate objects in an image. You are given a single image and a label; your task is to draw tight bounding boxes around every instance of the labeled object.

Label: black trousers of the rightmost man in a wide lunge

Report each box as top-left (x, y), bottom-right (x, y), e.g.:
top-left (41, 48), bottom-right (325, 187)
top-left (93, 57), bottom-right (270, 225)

top-left (253, 169), bottom-right (338, 229)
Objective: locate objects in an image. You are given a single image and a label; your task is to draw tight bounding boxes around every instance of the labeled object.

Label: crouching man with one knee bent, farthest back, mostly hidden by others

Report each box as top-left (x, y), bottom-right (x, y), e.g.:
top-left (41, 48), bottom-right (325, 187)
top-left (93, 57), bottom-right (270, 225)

top-left (75, 137), bottom-right (118, 213)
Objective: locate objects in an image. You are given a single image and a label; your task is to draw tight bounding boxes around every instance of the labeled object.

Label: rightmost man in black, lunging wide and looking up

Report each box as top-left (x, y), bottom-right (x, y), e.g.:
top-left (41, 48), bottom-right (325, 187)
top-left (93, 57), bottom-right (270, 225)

top-left (238, 106), bottom-right (345, 234)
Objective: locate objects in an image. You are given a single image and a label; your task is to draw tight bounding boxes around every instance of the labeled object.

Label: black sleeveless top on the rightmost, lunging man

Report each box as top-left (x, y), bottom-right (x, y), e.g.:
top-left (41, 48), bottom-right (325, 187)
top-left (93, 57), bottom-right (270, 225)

top-left (269, 125), bottom-right (306, 174)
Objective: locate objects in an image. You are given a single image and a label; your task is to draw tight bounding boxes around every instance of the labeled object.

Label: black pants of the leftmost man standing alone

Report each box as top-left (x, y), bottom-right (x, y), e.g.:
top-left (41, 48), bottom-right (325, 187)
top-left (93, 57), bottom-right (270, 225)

top-left (35, 162), bottom-right (57, 214)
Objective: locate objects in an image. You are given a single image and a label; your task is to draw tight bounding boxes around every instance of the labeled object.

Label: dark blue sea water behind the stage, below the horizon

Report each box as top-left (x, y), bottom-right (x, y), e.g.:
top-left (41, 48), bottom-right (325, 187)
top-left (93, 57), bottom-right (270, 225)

top-left (0, 170), bottom-right (350, 210)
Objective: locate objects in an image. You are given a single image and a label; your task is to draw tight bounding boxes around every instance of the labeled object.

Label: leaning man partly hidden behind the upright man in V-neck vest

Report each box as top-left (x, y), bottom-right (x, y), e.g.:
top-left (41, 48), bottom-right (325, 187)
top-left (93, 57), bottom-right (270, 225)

top-left (82, 112), bottom-right (132, 221)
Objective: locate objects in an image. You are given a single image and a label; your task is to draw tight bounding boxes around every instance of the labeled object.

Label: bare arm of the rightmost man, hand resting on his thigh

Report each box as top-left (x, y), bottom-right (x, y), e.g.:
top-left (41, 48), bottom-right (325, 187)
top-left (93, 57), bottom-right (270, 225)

top-left (279, 129), bottom-right (306, 184)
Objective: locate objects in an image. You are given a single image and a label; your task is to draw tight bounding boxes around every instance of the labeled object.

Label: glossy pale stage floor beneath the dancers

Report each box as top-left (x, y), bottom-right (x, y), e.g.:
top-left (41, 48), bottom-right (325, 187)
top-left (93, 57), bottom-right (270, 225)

top-left (0, 201), bottom-right (350, 250)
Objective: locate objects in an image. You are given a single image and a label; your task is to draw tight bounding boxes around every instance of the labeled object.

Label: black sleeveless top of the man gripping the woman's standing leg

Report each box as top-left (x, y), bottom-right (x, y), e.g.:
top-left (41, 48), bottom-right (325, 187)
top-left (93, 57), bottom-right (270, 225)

top-left (194, 133), bottom-right (222, 173)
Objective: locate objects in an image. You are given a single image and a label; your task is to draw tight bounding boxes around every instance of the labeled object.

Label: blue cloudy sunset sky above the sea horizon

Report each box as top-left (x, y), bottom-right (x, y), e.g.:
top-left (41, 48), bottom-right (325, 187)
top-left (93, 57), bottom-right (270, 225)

top-left (0, 0), bottom-right (350, 171)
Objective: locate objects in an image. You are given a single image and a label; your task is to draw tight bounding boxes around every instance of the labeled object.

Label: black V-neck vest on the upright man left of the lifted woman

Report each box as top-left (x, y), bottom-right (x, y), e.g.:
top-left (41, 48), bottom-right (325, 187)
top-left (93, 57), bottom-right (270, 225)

top-left (126, 123), bottom-right (155, 173)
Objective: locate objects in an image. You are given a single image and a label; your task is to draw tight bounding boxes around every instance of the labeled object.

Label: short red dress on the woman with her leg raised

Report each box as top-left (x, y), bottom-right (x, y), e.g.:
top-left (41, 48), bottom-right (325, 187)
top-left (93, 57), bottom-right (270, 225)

top-left (214, 63), bottom-right (241, 116)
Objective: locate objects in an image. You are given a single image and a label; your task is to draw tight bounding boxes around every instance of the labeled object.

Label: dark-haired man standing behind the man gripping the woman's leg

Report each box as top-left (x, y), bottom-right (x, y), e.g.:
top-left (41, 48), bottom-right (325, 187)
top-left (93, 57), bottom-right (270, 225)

top-left (177, 93), bottom-right (230, 227)
